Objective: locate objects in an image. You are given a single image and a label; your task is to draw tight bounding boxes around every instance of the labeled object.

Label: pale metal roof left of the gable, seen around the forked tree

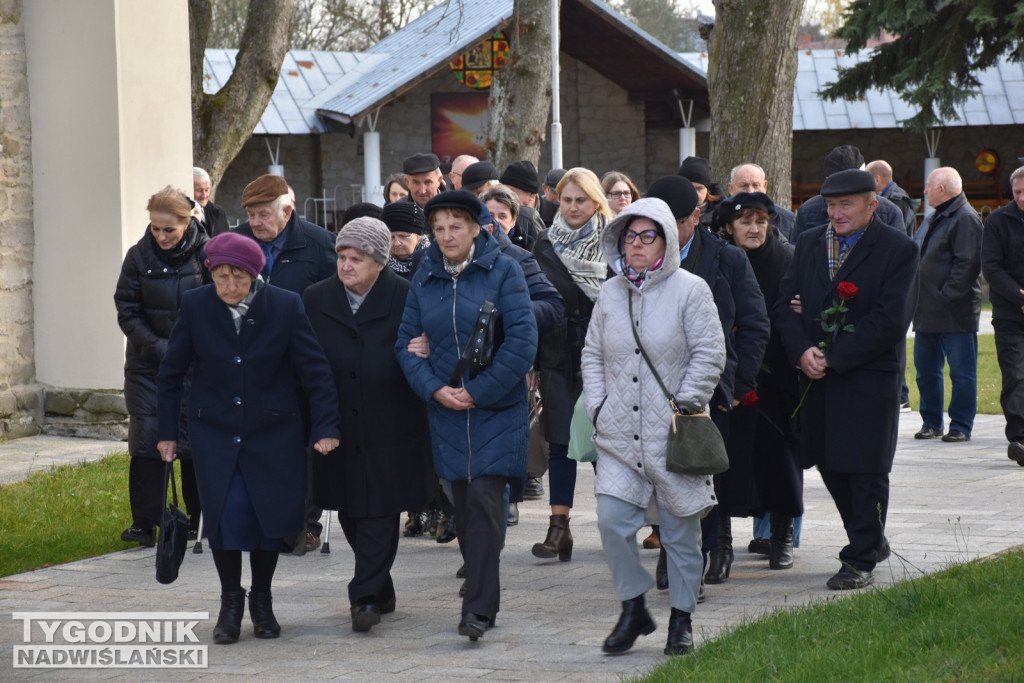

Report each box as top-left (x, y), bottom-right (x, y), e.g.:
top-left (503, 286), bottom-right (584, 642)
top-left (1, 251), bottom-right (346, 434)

top-left (203, 49), bottom-right (379, 135)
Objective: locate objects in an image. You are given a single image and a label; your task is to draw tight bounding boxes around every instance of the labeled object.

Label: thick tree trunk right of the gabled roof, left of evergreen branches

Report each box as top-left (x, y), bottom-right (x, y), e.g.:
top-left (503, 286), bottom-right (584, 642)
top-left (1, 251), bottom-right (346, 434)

top-left (708, 0), bottom-right (804, 208)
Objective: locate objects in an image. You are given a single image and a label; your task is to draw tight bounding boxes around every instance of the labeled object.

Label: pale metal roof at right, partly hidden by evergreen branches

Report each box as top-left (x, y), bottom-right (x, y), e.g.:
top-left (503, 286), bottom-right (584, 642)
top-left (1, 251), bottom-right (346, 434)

top-left (681, 48), bottom-right (1024, 130)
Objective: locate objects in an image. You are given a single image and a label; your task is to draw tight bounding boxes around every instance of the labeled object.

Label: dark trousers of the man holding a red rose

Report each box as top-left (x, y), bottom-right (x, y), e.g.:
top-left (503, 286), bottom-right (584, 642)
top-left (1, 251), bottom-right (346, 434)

top-left (818, 468), bottom-right (889, 571)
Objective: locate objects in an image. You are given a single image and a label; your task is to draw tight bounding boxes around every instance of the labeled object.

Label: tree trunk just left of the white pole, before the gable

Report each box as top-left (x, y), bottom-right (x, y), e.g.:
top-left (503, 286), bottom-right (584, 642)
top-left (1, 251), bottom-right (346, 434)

top-left (486, 0), bottom-right (551, 170)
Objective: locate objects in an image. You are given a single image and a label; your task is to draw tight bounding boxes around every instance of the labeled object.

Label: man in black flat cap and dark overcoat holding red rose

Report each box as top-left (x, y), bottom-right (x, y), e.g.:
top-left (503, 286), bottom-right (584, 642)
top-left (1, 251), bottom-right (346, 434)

top-left (772, 169), bottom-right (919, 590)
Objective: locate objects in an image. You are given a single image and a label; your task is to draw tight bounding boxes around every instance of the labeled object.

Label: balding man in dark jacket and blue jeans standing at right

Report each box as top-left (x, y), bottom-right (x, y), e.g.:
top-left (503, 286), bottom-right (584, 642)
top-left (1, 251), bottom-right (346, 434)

top-left (913, 167), bottom-right (981, 442)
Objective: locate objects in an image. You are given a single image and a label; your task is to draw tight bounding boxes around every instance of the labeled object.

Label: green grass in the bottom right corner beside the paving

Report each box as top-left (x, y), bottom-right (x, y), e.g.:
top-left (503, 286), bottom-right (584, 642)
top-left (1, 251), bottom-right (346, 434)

top-left (637, 551), bottom-right (1024, 683)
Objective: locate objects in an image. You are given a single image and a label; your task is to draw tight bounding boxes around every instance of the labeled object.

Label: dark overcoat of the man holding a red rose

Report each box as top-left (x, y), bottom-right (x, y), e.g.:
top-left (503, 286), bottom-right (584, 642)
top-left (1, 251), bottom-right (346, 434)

top-left (772, 216), bottom-right (919, 474)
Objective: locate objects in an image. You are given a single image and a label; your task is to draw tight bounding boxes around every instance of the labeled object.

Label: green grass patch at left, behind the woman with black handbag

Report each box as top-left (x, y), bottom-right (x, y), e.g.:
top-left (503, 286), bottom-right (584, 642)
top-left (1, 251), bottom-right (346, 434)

top-left (0, 454), bottom-right (148, 577)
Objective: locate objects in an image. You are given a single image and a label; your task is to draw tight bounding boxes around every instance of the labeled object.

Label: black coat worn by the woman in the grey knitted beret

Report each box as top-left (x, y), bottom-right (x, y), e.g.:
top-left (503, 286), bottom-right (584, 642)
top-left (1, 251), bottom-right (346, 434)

top-left (303, 266), bottom-right (437, 517)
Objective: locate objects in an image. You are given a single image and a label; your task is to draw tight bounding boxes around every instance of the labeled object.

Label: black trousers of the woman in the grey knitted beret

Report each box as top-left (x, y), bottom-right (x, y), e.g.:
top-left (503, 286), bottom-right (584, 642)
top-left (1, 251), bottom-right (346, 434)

top-left (338, 512), bottom-right (400, 605)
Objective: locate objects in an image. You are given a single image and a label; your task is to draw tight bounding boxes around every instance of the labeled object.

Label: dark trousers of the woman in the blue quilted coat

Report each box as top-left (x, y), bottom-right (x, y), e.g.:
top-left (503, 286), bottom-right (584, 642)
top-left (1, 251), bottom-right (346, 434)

top-left (452, 475), bottom-right (510, 618)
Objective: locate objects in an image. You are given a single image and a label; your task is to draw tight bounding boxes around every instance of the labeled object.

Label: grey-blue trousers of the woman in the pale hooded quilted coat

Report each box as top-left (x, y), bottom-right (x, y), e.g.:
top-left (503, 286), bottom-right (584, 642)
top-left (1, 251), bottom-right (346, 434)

top-left (597, 495), bottom-right (703, 613)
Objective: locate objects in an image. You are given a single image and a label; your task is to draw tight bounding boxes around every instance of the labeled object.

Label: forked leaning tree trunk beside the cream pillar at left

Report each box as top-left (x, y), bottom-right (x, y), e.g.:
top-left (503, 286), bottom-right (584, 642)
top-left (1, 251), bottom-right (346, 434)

top-left (188, 0), bottom-right (295, 187)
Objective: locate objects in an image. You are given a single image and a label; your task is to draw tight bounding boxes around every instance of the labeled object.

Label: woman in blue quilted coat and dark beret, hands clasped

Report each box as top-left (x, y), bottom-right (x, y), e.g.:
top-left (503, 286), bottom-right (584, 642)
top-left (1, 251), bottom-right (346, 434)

top-left (395, 190), bottom-right (537, 640)
